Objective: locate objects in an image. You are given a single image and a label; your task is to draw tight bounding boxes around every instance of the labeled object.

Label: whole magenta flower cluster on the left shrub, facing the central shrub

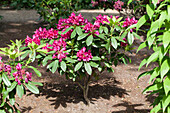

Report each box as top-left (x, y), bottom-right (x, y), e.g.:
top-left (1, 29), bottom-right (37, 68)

top-left (13, 63), bottom-right (32, 85)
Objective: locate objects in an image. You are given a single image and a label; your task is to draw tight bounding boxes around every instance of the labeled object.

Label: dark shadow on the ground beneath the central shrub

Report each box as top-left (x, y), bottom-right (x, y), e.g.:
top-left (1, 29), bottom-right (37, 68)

top-left (28, 77), bottom-right (128, 109)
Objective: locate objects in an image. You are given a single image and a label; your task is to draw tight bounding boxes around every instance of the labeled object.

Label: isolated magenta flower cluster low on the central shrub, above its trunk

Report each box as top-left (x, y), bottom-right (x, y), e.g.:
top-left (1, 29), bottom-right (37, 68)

top-left (77, 47), bottom-right (93, 61)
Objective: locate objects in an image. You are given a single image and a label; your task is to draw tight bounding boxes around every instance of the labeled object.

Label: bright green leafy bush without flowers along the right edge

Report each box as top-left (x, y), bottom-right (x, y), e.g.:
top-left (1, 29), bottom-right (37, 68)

top-left (137, 0), bottom-right (170, 113)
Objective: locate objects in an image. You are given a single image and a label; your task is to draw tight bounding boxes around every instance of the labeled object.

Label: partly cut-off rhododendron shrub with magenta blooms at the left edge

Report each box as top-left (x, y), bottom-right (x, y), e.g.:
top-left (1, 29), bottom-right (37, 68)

top-left (0, 40), bottom-right (42, 113)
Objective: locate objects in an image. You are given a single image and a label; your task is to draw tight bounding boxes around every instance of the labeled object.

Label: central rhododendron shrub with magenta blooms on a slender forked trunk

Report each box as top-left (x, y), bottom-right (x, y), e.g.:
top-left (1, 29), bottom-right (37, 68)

top-left (25, 13), bottom-right (137, 102)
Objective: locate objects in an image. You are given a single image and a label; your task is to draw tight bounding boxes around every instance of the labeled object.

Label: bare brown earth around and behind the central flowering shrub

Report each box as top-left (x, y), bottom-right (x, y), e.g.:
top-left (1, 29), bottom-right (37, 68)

top-left (0, 10), bottom-right (154, 113)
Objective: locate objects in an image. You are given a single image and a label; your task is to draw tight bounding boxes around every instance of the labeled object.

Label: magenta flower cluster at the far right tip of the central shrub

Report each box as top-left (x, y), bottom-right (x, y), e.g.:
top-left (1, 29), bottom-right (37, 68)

top-left (122, 17), bottom-right (138, 32)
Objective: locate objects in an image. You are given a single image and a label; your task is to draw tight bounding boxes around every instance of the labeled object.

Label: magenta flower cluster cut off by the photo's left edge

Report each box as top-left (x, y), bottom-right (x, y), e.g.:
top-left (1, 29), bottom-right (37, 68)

top-left (0, 57), bottom-right (11, 75)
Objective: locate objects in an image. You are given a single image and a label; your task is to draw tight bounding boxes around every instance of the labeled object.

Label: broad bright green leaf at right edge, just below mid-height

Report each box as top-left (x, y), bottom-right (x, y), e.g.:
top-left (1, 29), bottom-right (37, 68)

top-left (161, 59), bottom-right (170, 80)
